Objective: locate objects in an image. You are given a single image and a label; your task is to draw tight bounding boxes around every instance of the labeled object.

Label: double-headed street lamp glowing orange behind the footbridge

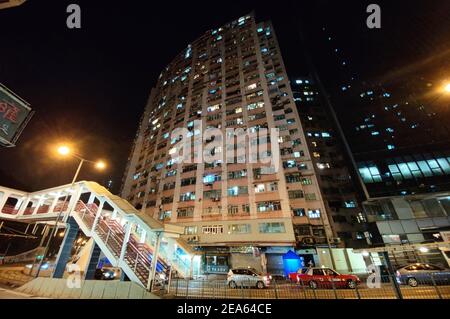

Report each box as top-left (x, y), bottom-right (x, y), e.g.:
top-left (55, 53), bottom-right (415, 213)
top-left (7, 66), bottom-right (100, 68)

top-left (30, 145), bottom-right (106, 278)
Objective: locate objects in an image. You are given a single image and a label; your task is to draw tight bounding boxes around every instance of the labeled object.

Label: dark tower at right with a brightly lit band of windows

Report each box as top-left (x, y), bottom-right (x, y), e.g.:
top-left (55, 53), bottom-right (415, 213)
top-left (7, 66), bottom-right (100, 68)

top-left (316, 21), bottom-right (450, 197)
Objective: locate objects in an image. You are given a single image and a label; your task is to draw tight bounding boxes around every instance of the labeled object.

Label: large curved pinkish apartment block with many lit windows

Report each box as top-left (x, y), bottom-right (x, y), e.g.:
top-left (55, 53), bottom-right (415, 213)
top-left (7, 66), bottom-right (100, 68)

top-left (122, 14), bottom-right (357, 273)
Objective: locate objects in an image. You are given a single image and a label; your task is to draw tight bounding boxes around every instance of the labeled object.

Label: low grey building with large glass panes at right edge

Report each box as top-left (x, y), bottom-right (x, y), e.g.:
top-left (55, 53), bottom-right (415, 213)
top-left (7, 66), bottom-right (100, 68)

top-left (363, 192), bottom-right (450, 267)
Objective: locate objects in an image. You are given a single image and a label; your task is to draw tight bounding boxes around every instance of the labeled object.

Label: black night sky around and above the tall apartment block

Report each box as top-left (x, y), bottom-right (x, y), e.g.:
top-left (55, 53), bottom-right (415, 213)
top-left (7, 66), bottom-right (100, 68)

top-left (0, 0), bottom-right (450, 191)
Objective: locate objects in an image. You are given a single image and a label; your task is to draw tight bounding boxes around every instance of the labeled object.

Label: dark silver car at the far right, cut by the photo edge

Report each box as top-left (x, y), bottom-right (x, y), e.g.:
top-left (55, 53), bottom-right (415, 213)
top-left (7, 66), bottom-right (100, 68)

top-left (396, 263), bottom-right (450, 287)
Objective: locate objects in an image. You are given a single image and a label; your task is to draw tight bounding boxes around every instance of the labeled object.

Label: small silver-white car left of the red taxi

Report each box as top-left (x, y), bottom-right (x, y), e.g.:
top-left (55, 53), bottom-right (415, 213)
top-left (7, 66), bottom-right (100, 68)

top-left (227, 268), bottom-right (272, 289)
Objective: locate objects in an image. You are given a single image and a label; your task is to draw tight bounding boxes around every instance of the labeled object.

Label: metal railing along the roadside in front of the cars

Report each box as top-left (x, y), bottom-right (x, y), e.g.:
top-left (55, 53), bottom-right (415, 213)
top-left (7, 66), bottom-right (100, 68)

top-left (158, 275), bottom-right (450, 299)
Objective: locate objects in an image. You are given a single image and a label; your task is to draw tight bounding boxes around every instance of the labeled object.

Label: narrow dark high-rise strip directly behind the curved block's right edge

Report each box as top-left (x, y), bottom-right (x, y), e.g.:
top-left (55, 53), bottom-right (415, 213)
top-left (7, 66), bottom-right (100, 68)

top-left (291, 77), bottom-right (370, 248)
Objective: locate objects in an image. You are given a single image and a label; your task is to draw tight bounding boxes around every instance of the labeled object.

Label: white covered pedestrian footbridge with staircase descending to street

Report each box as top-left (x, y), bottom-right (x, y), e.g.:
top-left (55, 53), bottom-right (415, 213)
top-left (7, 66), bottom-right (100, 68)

top-left (0, 181), bottom-right (199, 289)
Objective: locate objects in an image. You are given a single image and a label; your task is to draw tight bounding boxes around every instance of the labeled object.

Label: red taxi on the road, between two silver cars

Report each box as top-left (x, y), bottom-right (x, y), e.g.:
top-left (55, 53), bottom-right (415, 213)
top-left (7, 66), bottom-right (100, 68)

top-left (289, 267), bottom-right (361, 289)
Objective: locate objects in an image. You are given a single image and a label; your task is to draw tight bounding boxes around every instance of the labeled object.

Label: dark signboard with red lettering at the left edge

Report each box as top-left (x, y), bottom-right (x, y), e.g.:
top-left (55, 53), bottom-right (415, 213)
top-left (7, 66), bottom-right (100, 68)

top-left (0, 84), bottom-right (33, 147)
